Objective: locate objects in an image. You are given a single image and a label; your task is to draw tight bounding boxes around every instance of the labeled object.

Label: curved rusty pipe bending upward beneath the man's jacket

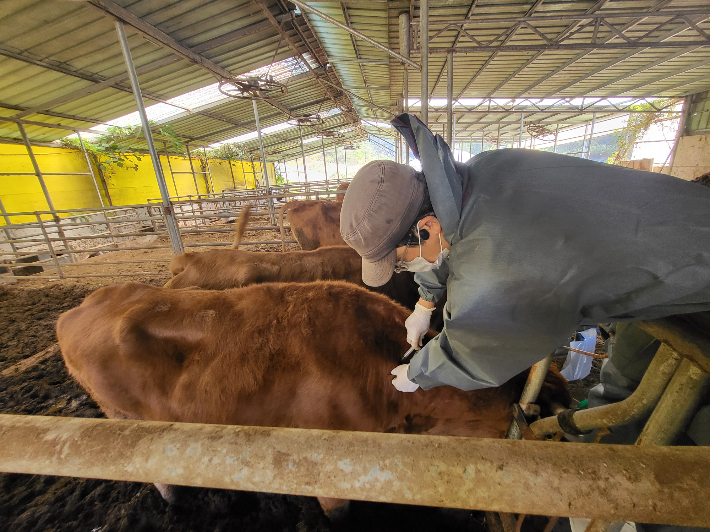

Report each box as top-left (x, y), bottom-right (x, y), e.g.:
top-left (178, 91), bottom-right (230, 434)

top-left (530, 344), bottom-right (681, 437)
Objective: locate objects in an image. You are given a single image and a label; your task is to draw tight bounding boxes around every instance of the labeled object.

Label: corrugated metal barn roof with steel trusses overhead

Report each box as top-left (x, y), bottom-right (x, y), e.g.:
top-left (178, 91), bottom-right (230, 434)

top-left (0, 0), bottom-right (710, 158)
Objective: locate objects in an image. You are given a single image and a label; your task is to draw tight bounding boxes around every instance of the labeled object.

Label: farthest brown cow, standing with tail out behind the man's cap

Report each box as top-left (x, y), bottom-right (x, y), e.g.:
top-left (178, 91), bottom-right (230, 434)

top-left (279, 200), bottom-right (345, 251)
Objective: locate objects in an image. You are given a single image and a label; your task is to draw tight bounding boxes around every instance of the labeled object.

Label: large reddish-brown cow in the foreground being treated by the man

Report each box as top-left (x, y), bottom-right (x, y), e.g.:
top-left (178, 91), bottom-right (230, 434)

top-left (57, 282), bottom-right (569, 510)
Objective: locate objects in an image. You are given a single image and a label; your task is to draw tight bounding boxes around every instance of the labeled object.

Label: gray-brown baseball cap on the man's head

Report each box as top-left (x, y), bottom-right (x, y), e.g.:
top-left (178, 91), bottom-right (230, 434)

top-left (340, 161), bottom-right (427, 286)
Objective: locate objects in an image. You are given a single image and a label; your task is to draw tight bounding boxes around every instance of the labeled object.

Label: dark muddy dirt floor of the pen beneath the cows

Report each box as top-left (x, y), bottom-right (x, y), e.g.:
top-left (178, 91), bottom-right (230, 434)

top-left (0, 217), bottom-right (596, 532)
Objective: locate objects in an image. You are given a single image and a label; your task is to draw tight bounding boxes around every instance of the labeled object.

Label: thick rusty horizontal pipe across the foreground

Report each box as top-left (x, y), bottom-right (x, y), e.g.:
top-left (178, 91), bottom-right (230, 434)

top-left (0, 415), bottom-right (710, 526)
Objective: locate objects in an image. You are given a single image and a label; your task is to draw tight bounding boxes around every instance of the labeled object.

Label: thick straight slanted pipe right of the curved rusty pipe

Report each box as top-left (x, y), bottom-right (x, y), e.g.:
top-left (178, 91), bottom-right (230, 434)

top-left (636, 359), bottom-right (710, 445)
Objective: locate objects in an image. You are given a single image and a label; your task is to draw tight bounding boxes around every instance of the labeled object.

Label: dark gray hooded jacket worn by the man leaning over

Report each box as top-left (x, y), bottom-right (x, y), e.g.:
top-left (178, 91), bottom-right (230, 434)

top-left (392, 115), bottom-right (710, 390)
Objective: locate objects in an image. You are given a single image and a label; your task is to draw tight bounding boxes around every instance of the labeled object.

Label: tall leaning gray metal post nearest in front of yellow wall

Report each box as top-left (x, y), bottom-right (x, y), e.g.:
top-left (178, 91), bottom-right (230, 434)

top-left (115, 20), bottom-right (184, 255)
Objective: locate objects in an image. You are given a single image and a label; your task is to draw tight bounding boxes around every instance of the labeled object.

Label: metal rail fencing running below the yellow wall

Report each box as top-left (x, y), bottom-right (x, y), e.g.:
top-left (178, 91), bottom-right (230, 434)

top-left (0, 182), bottom-right (344, 279)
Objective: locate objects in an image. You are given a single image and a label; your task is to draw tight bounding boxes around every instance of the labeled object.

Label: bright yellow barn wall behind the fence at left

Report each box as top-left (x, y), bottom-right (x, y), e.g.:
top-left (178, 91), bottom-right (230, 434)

top-left (0, 144), bottom-right (274, 225)
